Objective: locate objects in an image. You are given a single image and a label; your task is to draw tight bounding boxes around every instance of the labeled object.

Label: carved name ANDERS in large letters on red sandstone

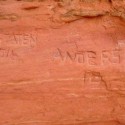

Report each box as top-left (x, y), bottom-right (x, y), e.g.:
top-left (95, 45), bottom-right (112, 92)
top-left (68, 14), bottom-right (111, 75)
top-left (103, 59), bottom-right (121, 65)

top-left (54, 48), bottom-right (121, 66)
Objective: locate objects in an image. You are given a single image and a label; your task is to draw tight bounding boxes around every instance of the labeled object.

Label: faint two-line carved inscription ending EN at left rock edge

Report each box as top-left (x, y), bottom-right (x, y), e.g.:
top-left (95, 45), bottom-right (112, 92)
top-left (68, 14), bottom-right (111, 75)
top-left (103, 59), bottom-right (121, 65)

top-left (0, 33), bottom-right (37, 62)
